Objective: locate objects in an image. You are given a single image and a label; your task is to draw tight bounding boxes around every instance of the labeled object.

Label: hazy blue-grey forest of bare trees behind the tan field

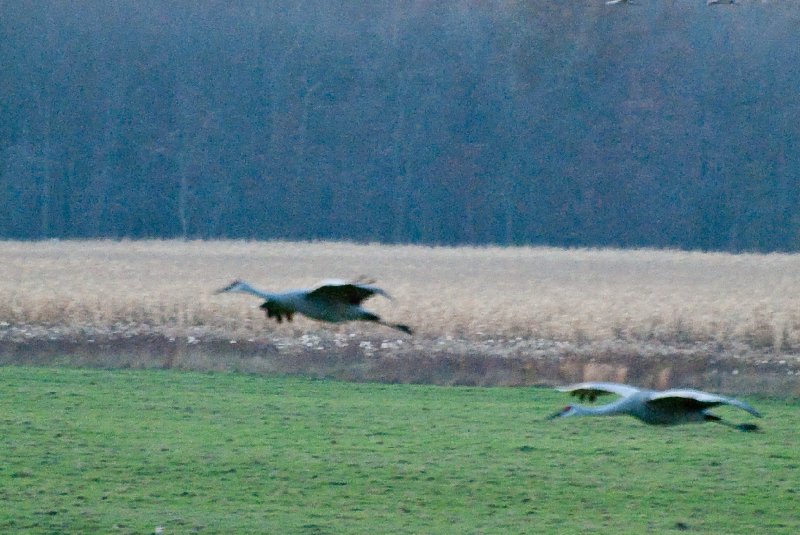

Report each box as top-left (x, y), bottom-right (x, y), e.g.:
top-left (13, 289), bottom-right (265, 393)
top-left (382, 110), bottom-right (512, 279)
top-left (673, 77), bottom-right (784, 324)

top-left (0, 0), bottom-right (800, 251)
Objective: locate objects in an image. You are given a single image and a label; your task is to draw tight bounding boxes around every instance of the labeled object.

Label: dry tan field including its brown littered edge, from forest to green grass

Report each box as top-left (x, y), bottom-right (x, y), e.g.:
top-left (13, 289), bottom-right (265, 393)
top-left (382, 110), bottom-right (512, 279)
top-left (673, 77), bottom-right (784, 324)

top-left (0, 241), bottom-right (800, 393)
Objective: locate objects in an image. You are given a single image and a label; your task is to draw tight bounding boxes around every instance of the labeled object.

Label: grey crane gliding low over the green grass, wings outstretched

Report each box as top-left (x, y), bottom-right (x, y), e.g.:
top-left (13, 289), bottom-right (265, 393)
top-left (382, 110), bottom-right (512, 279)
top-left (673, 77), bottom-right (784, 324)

top-left (550, 383), bottom-right (761, 431)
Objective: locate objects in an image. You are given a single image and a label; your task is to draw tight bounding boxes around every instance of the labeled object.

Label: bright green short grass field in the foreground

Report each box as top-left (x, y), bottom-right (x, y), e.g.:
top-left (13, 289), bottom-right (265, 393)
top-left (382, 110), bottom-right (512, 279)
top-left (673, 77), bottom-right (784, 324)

top-left (0, 367), bottom-right (800, 533)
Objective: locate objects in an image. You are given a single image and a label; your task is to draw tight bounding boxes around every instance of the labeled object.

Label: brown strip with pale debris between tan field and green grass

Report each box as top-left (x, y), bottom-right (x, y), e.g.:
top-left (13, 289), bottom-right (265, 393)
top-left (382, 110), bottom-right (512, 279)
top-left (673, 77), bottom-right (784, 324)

top-left (0, 331), bottom-right (800, 395)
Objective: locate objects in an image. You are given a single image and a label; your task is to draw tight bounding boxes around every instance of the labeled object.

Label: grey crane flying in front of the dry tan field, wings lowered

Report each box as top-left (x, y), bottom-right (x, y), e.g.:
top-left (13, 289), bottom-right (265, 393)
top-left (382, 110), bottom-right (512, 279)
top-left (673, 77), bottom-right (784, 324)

top-left (215, 278), bottom-right (412, 334)
